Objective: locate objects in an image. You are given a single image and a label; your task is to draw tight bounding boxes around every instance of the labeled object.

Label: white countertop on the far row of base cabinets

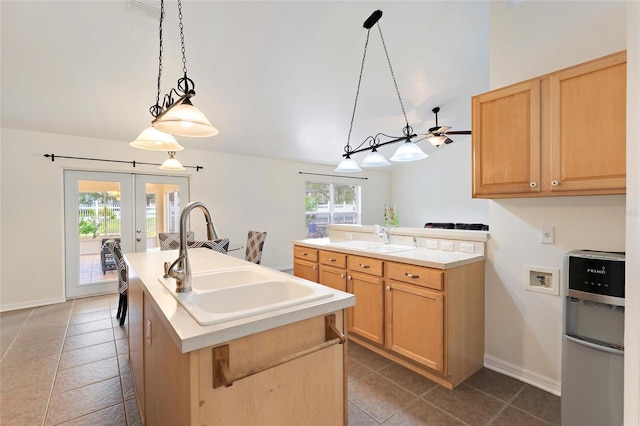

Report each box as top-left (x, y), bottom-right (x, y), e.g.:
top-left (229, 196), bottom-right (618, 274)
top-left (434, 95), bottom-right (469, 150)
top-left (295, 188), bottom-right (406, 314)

top-left (293, 238), bottom-right (485, 269)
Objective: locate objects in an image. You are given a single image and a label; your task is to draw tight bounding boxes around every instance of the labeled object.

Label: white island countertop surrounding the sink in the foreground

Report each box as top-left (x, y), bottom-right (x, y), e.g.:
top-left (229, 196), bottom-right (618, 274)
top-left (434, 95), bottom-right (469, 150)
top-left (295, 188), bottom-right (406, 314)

top-left (124, 248), bottom-right (355, 353)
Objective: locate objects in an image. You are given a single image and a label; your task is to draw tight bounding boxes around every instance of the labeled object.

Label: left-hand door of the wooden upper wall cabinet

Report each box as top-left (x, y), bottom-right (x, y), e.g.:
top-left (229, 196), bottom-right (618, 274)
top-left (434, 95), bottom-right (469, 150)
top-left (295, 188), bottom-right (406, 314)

top-left (472, 80), bottom-right (541, 197)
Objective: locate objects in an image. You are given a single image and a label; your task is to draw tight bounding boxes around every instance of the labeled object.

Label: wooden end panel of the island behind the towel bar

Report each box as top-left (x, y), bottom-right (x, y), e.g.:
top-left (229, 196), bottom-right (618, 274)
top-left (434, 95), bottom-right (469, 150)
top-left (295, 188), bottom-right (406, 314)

top-left (198, 311), bottom-right (347, 426)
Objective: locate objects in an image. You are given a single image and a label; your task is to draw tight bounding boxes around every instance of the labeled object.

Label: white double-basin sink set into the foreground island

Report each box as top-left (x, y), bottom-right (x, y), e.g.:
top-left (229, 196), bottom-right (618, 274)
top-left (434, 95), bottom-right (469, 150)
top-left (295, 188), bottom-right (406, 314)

top-left (159, 268), bottom-right (332, 325)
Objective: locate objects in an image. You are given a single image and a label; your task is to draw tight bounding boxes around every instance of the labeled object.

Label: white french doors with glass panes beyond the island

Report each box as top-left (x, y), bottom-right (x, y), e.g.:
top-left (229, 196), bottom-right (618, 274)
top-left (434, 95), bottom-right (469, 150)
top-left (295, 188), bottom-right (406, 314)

top-left (64, 170), bottom-right (189, 298)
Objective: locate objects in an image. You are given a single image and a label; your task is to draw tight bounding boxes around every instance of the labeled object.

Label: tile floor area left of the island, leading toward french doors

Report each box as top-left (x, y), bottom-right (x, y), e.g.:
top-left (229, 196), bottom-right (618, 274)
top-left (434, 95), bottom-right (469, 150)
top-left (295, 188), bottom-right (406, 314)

top-left (0, 294), bottom-right (141, 426)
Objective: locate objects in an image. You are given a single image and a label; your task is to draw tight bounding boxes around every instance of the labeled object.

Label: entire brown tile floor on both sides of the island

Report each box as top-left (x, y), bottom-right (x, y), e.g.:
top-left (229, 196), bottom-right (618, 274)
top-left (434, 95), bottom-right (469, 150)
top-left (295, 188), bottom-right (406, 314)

top-left (0, 294), bottom-right (560, 426)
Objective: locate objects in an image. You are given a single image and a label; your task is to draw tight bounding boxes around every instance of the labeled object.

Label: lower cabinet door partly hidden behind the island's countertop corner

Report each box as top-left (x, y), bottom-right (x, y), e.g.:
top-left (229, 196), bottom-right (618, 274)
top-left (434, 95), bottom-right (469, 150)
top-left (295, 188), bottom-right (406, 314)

top-left (347, 272), bottom-right (384, 345)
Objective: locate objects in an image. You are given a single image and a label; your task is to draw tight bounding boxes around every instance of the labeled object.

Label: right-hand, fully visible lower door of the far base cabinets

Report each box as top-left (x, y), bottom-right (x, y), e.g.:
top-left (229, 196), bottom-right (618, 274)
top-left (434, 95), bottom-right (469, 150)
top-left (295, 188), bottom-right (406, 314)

top-left (382, 280), bottom-right (444, 373)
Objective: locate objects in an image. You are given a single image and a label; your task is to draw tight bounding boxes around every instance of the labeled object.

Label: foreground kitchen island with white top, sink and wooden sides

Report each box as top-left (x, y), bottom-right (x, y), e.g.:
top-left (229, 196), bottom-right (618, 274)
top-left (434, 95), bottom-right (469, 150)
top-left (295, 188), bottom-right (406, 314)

top-left (125, 248), bottom-right (354, 425)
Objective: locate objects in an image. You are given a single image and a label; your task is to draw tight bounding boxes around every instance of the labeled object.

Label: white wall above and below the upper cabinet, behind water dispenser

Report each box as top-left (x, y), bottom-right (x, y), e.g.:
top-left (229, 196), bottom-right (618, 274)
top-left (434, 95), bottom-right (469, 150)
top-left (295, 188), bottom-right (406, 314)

top-left (485, 1), bottom-right (626, 393)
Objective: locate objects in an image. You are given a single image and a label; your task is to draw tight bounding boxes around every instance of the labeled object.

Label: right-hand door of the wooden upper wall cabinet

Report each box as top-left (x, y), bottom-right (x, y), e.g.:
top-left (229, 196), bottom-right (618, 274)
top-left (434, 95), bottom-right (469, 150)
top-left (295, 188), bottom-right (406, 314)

top-left (549, 52), bottom-right (627, 193)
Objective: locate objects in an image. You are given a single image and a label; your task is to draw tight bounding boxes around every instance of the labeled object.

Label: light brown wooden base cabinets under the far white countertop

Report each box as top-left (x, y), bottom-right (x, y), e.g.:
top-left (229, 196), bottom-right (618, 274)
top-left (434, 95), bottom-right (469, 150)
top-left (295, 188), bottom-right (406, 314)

top-left (294, 246), bottom-right (484, 389)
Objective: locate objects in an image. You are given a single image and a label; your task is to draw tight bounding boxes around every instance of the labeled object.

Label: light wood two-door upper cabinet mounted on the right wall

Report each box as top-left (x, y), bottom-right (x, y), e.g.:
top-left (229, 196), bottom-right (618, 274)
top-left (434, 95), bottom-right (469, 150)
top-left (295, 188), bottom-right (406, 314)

top-left (472, 52), bottom-right (626, 198)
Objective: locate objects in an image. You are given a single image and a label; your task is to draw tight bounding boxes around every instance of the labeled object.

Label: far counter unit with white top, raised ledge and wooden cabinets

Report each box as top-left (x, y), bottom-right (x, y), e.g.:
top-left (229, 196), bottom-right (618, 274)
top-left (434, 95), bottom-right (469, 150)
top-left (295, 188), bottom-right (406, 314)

top-left (293, 225), bottom-right (488, 389)
